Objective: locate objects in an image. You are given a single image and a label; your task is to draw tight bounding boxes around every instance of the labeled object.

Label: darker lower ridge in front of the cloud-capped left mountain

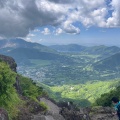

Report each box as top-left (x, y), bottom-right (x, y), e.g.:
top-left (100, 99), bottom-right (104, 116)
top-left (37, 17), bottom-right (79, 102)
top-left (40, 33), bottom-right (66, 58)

top-left (4, 48), bottom-right (73, 64)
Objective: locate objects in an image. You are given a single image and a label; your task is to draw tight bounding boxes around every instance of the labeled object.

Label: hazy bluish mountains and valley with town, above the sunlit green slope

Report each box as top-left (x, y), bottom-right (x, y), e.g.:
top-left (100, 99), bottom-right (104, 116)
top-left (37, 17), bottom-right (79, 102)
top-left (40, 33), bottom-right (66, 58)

top-left (0, 39), bottom-right (120, 85)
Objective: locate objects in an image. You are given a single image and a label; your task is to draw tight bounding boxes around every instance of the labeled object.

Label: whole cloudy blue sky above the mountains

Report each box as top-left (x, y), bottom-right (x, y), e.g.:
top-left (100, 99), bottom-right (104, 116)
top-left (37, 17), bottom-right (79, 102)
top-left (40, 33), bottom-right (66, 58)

top-left (0, 0), bottom-right (120, 46)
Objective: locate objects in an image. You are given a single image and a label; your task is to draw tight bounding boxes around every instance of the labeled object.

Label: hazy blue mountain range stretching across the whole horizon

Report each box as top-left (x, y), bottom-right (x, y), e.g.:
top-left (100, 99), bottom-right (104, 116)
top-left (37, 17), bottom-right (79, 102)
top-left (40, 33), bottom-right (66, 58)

top-left (0, 38), bottom-right (120, 56)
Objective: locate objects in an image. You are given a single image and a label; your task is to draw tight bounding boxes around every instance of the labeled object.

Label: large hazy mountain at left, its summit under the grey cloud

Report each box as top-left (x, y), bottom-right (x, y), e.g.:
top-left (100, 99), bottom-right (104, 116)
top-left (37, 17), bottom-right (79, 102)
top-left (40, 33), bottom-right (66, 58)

top-left (0, 39), bottom-right (72, 66)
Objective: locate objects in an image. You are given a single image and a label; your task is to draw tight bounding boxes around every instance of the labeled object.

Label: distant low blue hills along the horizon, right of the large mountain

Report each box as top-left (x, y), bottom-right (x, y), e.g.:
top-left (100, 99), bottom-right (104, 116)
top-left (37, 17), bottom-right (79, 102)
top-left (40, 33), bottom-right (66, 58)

top-left (49, 44), bottom-right (120, 58)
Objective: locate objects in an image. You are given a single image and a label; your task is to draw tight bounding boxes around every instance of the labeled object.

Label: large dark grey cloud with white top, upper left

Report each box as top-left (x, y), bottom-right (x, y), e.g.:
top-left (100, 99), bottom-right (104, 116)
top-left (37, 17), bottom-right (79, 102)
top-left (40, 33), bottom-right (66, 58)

top-left (0, 0), bottom-right (64, 37)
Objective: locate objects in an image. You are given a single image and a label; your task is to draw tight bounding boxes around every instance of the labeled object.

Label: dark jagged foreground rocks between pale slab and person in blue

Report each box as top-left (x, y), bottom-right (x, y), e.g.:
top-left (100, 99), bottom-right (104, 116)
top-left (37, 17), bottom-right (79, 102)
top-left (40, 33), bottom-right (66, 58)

top-left (61, 107), bottom-right (118, 120)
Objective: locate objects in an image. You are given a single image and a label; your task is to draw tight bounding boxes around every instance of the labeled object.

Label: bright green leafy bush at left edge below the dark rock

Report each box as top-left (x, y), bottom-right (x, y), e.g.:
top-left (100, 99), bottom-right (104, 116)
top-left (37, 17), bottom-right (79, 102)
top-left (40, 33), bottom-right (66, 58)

top-left (0, 62), bottom-right (20, 119)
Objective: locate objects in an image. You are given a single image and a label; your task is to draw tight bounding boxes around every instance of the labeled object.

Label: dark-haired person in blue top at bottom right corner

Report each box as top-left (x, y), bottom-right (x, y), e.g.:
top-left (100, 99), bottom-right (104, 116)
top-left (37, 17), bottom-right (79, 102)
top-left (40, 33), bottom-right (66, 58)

top-left (111, 97), bottom-right (120, 120)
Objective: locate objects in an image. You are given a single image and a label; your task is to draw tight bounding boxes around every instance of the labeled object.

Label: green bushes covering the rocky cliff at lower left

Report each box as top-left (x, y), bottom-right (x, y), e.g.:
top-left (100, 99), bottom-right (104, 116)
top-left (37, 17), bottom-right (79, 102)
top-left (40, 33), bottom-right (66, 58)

top-left (0, 60), bottom-right (47, 120)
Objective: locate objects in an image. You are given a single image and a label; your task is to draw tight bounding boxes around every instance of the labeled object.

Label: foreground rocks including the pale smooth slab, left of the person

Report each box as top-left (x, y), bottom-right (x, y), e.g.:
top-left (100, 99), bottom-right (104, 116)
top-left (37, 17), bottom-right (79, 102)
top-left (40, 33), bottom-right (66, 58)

top-left (32, 98), bottom-right (117, 120)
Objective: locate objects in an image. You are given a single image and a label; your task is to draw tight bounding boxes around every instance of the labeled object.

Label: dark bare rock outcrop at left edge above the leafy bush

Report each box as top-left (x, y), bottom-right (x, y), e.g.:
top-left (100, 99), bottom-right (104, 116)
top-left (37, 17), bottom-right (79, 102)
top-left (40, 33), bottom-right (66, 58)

top-left (0, 55), bottom-right (17, 72)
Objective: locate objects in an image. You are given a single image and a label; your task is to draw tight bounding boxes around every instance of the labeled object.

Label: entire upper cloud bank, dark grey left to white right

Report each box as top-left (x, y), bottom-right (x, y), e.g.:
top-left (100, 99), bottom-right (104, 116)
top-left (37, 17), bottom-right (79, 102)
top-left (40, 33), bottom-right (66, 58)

top-left (0, 0), bottom-right (120, 38)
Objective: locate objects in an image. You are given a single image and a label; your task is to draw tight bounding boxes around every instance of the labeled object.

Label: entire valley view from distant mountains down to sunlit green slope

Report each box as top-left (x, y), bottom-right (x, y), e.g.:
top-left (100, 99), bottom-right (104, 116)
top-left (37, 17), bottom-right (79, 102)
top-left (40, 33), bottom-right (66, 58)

top-left (0, 40), bottom-right (120, 106)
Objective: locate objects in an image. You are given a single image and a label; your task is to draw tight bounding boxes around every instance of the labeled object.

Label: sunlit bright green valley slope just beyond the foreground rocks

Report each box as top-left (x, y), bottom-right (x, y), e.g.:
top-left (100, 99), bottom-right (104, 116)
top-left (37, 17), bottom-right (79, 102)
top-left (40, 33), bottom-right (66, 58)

top-left (38, 79), bottom-right (120, 107)
